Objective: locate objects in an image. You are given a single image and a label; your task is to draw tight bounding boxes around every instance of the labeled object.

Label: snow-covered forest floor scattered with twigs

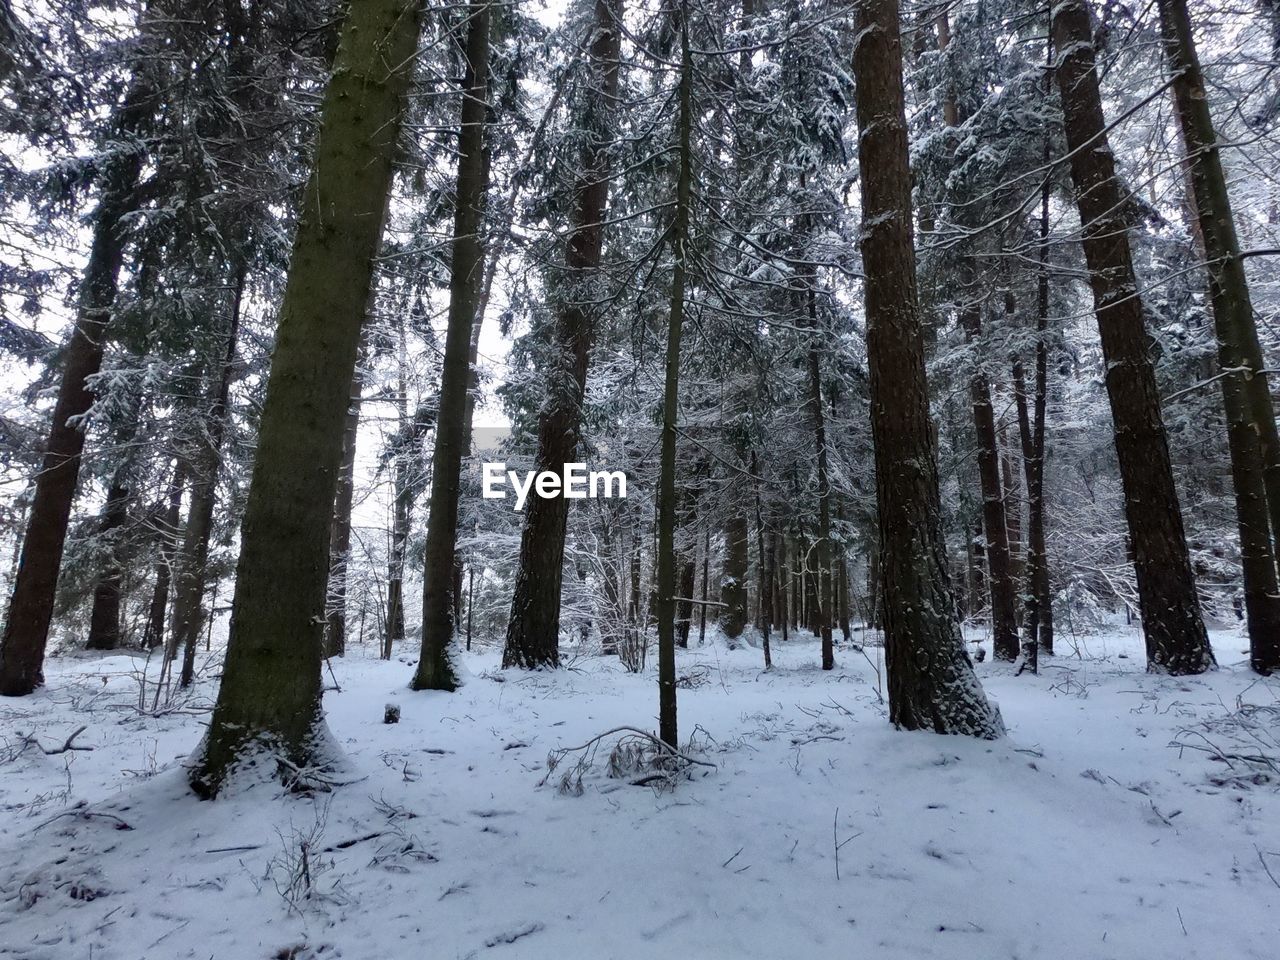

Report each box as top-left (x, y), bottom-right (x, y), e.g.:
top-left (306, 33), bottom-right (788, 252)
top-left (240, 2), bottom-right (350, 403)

top-left (0, 627), bottom-right (1280, 960)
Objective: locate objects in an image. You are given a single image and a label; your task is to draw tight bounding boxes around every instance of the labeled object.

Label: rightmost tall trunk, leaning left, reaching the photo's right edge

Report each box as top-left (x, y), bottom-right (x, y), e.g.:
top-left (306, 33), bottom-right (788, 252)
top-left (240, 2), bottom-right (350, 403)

top-left (1157, 0), bottom-right (1280, 673)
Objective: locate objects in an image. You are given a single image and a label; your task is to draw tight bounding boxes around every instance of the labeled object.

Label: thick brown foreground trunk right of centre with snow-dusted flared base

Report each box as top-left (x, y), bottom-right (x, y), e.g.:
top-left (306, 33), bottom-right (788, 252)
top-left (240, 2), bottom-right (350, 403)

top-left (854, 0), bottom-right (1002, 737)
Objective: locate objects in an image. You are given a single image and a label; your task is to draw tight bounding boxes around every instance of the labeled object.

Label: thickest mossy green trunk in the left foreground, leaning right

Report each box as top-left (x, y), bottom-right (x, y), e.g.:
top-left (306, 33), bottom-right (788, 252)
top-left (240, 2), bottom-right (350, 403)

top-left (191, 0), bottom-right (419, 797)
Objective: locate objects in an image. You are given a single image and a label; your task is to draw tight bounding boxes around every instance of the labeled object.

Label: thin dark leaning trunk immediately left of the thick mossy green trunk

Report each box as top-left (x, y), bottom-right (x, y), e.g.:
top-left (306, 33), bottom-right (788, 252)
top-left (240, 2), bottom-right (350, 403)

top-left (170, 265), bottom-right (246, 687)
